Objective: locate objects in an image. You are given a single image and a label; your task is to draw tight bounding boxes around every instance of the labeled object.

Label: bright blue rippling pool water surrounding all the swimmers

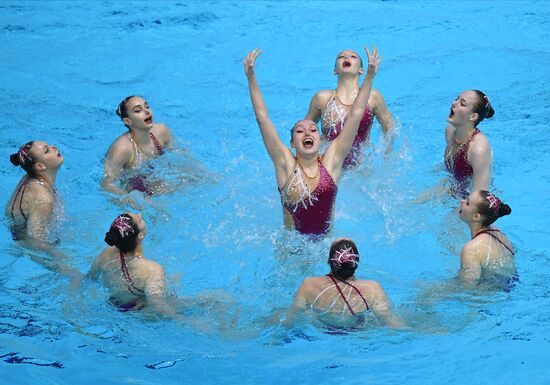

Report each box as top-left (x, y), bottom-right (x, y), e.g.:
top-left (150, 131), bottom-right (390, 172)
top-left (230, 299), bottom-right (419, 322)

top-left (0, 1), bottom-right (550, 384)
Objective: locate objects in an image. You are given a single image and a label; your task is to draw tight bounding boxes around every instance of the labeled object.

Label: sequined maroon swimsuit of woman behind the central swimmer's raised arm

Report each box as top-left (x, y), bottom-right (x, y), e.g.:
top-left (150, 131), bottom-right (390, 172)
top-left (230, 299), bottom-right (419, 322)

top-left (321, 91), bottom-right (374, 169)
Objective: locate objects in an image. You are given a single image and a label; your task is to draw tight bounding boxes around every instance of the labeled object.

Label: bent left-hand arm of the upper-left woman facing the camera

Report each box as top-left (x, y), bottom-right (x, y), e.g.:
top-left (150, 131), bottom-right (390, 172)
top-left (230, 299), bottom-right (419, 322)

top-left (101, 137), bottom-right (134, 195)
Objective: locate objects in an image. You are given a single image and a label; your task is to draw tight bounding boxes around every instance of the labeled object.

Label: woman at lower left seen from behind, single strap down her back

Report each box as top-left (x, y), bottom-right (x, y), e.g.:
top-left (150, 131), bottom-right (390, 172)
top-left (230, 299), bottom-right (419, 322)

top-left (87, 213), bottom-right (174, 315)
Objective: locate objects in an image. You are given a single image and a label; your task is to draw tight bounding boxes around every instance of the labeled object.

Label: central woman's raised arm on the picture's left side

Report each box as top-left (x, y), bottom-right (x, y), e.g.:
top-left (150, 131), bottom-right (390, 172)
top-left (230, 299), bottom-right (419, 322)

top-left (247, 48), bottom-right (294, 184)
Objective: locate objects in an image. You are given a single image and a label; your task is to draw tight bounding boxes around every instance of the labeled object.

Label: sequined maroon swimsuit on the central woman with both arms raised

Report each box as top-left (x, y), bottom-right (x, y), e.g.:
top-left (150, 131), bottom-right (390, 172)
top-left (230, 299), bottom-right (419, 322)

top-left (279, 158), bottom-right (338, 235)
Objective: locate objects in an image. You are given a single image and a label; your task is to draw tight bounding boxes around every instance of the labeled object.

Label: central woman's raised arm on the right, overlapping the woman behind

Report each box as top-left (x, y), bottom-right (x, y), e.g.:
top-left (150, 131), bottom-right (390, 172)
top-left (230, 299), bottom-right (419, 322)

top-left (323, 47), bottom-right (382, 175)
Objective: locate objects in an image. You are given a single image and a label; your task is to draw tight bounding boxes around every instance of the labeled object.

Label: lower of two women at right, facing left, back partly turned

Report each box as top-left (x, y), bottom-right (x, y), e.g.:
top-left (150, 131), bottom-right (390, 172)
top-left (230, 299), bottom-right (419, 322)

top-left (459, 190), bottom-right (517, 287)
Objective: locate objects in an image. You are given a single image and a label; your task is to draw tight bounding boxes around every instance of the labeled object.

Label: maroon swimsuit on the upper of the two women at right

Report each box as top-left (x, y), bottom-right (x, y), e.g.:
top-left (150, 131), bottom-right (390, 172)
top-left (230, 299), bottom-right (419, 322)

top-left (445, 128), bottom-right (480, 197)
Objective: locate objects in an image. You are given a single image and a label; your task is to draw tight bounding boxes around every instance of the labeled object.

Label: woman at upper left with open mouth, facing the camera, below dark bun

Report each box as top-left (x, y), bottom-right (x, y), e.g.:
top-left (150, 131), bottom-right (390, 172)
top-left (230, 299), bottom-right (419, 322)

top-left (101, 96), bottom-right (172, 195)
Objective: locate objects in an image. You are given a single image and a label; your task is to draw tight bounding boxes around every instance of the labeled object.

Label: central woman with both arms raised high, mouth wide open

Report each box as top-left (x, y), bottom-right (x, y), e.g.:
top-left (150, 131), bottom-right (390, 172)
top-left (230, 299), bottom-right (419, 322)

top-left (243, 47), bottom-right (381, 235)
